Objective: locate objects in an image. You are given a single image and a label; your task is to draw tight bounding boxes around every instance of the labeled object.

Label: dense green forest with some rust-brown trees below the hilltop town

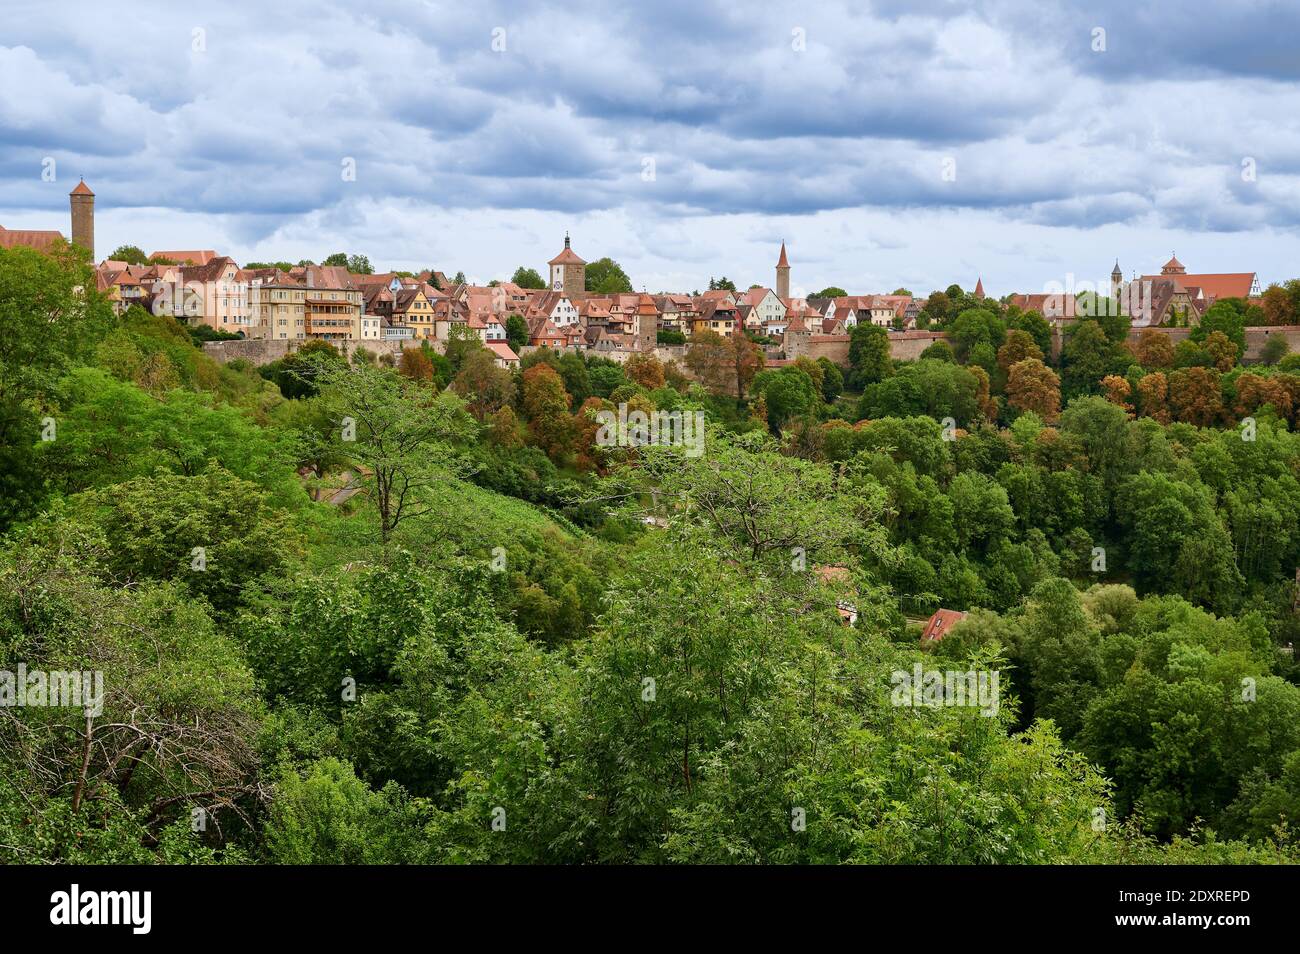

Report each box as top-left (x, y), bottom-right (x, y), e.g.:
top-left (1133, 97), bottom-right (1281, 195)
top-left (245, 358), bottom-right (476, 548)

top-left (0, 240), bottom-right (1300, 864)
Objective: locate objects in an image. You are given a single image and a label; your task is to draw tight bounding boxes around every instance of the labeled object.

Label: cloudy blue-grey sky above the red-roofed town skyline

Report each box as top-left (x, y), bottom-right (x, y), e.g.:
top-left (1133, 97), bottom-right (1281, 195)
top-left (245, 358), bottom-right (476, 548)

top-left (0, 0), bottom-right (1300, 295)
